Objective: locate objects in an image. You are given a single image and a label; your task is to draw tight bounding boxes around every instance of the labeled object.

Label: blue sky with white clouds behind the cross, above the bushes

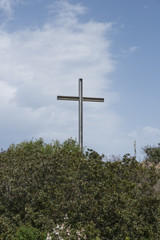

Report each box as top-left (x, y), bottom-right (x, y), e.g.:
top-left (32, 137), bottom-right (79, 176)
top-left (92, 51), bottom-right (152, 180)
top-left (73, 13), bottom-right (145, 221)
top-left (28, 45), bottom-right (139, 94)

top-left (0, 0), bottom-right (160, 159)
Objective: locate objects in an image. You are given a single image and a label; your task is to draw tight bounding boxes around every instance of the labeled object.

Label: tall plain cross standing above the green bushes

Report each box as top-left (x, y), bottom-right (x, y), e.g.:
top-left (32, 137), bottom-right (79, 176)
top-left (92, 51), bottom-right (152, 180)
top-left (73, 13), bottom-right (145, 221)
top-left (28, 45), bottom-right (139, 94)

top-left (57, 78), bottom-right (104, 148)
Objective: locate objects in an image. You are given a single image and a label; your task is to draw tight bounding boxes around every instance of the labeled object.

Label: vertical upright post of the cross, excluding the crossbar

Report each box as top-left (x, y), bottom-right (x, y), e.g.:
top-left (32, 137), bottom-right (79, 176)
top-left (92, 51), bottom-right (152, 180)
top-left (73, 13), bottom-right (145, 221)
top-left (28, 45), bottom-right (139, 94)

top-left (79, 78), bottom-right (83, 148)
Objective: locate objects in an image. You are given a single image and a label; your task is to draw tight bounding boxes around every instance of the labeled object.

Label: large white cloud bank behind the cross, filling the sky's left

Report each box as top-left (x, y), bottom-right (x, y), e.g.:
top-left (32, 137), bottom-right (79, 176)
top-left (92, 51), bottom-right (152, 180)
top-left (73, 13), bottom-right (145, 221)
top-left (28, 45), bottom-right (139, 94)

top-left (0, 1), bottom-right (120, 152)
